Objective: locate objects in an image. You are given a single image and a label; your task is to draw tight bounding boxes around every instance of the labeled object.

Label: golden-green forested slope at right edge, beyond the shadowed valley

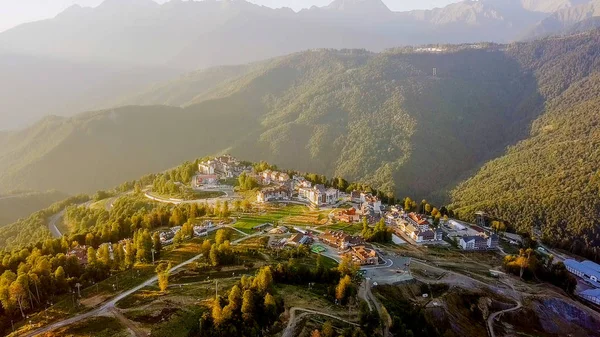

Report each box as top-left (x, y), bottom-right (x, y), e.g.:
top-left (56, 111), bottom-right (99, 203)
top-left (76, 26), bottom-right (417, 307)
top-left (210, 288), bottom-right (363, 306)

top-left (452, 32), bottom-right (600, 259)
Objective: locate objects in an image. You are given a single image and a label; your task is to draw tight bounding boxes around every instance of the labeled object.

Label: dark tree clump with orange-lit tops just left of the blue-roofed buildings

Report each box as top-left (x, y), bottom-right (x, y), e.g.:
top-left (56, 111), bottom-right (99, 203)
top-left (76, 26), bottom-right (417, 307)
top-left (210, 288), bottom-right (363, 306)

top-left (503, 248), bottom-right (577, 294)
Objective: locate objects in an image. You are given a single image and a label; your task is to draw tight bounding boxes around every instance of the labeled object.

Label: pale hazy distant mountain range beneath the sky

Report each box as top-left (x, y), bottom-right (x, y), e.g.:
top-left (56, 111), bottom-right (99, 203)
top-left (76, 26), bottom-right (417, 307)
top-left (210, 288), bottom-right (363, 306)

top-left (0, 0), bottom-right (599, 129)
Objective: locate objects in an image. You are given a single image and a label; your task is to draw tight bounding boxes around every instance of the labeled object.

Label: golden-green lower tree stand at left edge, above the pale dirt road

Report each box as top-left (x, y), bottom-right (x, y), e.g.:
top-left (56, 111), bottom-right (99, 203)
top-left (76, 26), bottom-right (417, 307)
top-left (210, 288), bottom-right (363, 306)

top-left (0, 230), bottom-right (153, 331)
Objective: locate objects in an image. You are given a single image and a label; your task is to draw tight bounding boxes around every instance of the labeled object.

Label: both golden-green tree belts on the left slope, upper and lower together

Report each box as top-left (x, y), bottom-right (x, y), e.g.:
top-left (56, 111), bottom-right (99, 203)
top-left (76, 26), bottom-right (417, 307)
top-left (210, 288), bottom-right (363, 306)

top-left (0, 196), bottom-right (170, 329)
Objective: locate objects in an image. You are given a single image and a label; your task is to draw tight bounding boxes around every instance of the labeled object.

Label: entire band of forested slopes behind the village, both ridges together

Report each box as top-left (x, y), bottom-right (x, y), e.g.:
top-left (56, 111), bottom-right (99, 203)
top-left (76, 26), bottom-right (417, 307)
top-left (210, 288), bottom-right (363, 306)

top-left (0, 31), bottom-right (600, 258)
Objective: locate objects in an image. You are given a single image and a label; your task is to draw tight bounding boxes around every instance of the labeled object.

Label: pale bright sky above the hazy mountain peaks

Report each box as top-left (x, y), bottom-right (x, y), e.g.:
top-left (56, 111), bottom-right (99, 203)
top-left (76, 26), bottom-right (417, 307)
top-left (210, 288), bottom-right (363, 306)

top-left (0, 0), bottom-right (460, 32)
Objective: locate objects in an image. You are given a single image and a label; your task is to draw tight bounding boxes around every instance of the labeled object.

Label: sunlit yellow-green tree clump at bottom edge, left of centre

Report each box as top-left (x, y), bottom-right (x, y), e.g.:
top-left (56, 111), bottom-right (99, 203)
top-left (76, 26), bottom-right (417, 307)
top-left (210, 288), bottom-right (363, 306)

top-left (199, 266), bottom-right (283, 337)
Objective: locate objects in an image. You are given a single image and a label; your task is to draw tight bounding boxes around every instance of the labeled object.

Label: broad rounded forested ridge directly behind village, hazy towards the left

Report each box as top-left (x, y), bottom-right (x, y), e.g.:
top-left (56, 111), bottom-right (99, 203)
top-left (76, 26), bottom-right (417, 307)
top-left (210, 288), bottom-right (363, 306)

top-left (0, 46), bottom-right (542, 199)
